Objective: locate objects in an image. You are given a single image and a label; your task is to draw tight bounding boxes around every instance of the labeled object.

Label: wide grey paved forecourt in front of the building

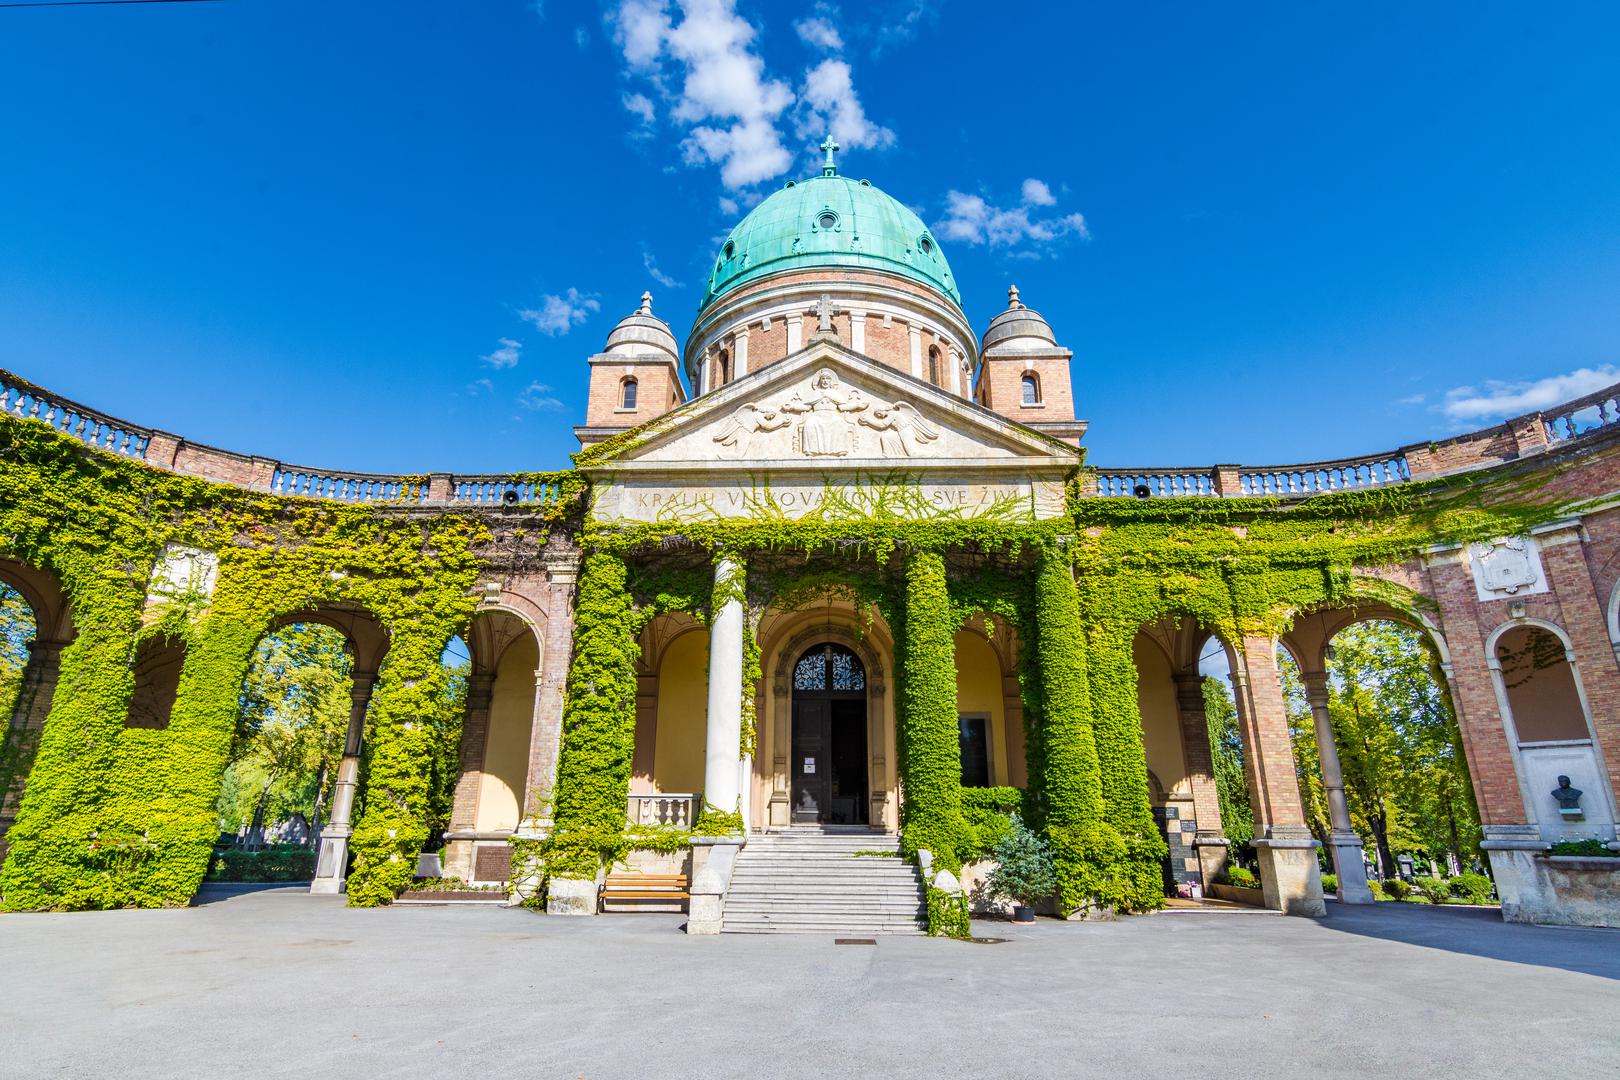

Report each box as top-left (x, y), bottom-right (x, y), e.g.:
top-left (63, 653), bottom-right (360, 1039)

top-left (0, 889), bottom-right (1620, 1080)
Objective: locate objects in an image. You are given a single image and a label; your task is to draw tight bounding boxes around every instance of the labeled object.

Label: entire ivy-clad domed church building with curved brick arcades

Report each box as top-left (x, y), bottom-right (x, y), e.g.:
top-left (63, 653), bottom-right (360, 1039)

top-left (0, 147), bottom-right (1620, 933)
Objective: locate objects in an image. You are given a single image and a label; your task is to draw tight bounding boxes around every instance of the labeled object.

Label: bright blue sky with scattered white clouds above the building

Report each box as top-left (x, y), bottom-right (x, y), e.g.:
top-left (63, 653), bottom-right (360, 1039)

top-left (0, 0), bottom-right (1620, 471)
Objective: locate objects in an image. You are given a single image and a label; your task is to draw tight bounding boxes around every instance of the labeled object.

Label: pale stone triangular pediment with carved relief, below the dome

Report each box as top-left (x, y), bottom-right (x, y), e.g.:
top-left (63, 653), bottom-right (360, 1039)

top-left (590, 340), bottom-right (1079, 473)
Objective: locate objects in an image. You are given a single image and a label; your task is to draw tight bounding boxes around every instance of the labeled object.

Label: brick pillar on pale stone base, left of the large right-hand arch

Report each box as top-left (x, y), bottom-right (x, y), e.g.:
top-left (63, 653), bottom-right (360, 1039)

top-left (1233, 636), bottom-right (1327, 916)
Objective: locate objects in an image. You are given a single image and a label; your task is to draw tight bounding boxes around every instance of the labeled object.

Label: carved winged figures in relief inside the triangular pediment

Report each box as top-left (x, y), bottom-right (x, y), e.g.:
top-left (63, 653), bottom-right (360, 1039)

top-left (714, 368), bottom-right (940, 458)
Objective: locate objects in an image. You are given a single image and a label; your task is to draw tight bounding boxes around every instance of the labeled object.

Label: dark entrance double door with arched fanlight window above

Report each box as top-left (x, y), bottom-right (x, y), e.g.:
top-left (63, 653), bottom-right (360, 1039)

top-left (789, 643), bottom-right (870, 824)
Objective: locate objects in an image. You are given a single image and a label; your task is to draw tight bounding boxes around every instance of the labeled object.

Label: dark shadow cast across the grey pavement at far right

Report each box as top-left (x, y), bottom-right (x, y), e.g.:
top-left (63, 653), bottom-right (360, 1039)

top-left (1319, 904), bottom-right (1620, 980)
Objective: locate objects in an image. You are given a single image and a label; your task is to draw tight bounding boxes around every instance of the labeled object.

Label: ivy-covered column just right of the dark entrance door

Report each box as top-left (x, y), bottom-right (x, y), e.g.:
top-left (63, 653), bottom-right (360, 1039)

top-left (896, 552), bottom-right (974, 871)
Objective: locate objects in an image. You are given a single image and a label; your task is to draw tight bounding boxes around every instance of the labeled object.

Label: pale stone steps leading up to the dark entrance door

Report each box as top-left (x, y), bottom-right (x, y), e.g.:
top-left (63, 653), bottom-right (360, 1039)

top-left (724, 826), bottom-right (925, 936)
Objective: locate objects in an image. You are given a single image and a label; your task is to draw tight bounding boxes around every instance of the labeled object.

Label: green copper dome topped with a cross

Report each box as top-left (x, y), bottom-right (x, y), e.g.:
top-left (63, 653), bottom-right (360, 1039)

top-left (703, 144), bottom-right (962, 308)
